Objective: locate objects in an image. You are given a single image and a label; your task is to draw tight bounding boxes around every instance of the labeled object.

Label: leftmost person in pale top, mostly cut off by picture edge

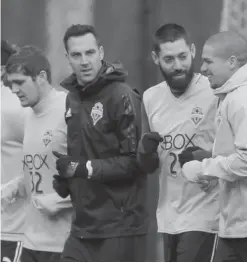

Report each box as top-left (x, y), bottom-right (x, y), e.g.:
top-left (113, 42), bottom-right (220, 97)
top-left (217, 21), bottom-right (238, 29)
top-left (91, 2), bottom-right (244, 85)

top-left (1, 40), bottom-right (25, 261)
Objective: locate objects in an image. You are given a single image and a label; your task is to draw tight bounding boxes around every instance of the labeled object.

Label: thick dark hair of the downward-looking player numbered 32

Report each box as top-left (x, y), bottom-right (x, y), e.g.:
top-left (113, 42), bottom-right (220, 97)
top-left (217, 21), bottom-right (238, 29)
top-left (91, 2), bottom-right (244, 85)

top-left (6, 46), bottom-right (51, 83)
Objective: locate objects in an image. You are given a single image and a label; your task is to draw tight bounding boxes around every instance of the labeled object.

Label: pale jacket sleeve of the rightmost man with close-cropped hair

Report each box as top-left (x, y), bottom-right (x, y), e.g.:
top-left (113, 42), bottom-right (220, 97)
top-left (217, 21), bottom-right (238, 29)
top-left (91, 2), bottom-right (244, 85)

top-left (202, 102), bottom-right (247, 182)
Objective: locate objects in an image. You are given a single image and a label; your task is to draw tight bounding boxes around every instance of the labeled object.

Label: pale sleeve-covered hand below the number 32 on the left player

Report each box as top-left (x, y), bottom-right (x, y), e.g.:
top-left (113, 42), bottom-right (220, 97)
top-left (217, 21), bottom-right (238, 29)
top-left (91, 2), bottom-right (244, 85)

top-left (32, 193), bottom-right (72, 216)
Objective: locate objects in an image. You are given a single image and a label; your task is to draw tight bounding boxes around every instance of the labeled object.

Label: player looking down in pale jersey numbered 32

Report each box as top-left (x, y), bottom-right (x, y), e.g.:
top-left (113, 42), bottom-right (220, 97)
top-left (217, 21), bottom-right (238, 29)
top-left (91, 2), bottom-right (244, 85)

top-left (6, 46), bottom-right (71, 261)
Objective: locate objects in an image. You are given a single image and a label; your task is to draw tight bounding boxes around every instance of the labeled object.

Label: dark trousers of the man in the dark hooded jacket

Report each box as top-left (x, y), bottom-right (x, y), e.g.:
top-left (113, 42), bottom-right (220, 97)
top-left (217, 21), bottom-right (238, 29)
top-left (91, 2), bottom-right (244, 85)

top-left (61, 235), bottom-right (147, 262)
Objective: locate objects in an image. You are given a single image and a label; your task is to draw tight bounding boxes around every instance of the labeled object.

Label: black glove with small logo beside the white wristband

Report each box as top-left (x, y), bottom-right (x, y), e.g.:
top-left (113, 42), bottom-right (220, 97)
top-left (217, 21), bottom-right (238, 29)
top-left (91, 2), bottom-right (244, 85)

top-left (53, 152), bottom-right (88, 178)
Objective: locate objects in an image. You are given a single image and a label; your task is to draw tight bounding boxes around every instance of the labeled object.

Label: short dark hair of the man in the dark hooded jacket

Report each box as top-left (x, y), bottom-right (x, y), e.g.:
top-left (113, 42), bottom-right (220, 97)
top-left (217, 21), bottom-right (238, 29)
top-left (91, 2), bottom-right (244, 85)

top-left (63, 24), bottom-right (100, 51)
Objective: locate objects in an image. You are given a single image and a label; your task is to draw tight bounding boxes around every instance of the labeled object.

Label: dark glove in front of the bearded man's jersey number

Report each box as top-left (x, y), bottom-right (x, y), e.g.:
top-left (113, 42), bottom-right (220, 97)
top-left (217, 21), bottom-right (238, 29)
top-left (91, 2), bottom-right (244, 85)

top-left (178, 146), bottom-right (212, 167)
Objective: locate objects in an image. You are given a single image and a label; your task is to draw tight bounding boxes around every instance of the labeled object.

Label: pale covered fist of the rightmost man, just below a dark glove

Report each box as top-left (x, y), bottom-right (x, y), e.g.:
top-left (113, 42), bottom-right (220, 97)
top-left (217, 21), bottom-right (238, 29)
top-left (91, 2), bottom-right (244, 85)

top-left (182, 160), bottom-right (205, 183)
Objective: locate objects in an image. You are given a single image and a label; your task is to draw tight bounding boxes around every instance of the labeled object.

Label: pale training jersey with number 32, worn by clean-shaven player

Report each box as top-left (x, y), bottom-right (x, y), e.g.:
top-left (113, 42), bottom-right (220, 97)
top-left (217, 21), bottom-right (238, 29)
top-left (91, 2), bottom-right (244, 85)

top-left (23, 89), bottom-right (72, 252)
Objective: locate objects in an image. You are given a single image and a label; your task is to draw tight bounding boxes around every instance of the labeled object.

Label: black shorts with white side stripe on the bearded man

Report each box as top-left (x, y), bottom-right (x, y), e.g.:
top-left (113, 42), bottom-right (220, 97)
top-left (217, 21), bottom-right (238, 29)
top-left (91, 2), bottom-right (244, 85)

top-left (163, 231), bottom-right (217, 262)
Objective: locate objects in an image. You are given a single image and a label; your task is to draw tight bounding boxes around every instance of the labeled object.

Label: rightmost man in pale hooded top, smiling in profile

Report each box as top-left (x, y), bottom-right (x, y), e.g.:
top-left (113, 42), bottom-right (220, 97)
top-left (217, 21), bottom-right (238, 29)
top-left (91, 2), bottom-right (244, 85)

top-left (183, 31), bottom-right (247, 262)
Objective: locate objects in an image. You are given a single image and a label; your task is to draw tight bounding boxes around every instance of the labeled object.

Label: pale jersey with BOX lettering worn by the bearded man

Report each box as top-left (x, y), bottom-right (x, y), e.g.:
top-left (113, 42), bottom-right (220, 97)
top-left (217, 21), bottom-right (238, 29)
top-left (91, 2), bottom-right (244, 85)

top-left (143, 74), bottom-right (219, 234)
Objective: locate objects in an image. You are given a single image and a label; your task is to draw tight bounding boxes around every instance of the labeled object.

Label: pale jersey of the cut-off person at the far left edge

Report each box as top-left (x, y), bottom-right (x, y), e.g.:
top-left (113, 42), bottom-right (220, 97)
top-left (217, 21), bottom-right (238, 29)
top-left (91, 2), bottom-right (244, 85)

top-left (1, 83), bottom-right (25, 241)
